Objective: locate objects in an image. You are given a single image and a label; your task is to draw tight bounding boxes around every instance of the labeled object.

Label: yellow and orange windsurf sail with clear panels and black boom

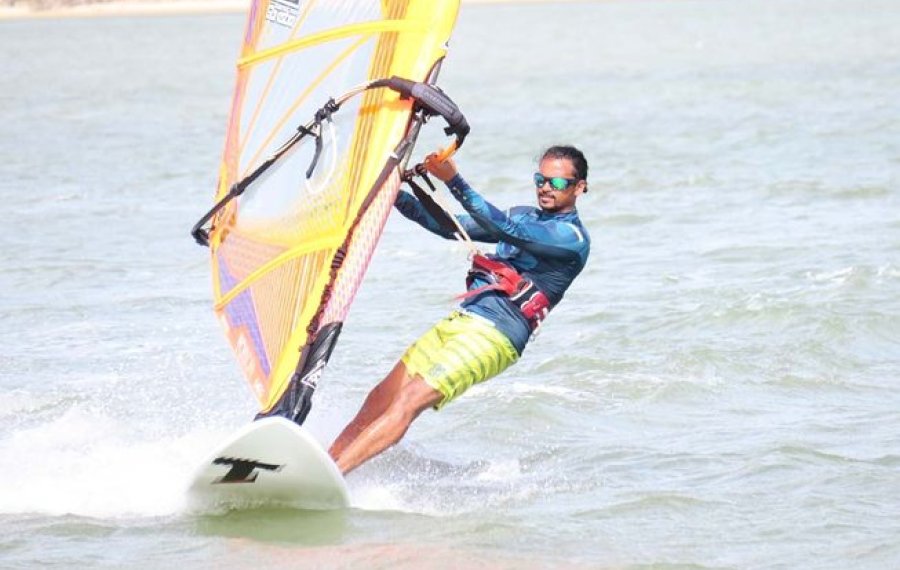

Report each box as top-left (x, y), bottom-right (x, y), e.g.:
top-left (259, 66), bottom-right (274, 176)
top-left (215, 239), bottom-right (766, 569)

top-left (192, 0), bottom-right (468, 423)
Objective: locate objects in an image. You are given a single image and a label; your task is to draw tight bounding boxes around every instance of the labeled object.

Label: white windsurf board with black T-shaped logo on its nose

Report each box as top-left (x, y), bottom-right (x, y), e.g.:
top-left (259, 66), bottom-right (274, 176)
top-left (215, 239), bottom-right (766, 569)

top-left (188, 417), bottom-right (350, 510)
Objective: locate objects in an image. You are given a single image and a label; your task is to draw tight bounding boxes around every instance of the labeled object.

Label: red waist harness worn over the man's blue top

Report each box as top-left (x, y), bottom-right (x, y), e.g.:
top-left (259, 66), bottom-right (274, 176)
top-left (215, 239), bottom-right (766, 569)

top-left (460, 253), bottom-right (552, 332)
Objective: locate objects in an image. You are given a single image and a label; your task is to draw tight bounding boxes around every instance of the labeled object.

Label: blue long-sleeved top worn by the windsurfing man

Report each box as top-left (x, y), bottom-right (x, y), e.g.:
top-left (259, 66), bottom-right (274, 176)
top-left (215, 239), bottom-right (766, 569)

top-left (394, 174), bottom-right (591, 354)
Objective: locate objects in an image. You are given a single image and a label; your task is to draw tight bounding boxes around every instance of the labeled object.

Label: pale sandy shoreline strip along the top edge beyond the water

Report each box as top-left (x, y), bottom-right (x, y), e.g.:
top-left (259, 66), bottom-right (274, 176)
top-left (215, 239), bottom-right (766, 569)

top-left (0, 0), bottom-right (585, 22)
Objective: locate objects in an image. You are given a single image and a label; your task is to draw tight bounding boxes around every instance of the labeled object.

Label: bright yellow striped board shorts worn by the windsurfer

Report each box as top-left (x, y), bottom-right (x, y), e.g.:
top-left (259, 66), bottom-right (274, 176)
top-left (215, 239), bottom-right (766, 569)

top-left (400, 311), bottom-right (519, 410)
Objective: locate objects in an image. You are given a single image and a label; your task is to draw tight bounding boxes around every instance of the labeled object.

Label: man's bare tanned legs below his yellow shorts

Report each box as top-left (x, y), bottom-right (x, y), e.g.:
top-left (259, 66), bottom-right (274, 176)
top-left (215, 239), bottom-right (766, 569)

top-left (329, 370), bottom-right (443, 475)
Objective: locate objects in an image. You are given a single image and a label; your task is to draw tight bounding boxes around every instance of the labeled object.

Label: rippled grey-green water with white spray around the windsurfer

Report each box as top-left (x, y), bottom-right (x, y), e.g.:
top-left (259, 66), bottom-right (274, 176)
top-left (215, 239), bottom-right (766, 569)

top-left (0, 0), bottom-right (900, 569)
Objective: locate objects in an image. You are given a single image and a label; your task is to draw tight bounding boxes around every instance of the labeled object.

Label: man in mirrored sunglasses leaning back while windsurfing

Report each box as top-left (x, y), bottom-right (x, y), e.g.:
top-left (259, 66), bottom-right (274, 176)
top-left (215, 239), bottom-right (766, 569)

top-left (329, 146), bottom-right (590, 474)
